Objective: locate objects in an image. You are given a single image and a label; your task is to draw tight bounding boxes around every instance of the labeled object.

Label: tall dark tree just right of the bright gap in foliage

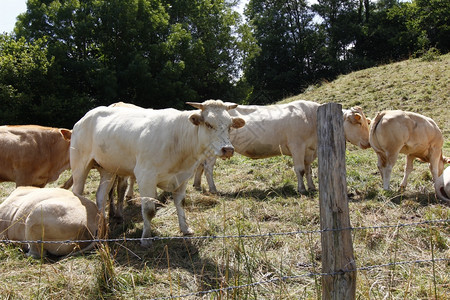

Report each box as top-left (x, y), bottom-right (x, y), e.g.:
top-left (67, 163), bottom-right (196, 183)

top-left (244, 0), bottom-right (322, 103)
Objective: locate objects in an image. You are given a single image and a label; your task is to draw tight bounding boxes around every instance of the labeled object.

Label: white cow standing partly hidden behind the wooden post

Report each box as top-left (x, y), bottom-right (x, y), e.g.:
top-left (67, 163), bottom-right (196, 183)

top-left (194, 100), bottom-right (370, 193)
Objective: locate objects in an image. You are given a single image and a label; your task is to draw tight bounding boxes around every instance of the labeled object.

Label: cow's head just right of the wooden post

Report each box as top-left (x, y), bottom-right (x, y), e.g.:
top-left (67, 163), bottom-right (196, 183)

top-left (343, 106), bottom-right (371, 149)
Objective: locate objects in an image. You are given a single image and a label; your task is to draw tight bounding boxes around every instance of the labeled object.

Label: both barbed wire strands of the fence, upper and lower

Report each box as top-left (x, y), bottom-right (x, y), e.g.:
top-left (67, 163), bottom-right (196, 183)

top-left (0, 219), bottom-right (450, 300)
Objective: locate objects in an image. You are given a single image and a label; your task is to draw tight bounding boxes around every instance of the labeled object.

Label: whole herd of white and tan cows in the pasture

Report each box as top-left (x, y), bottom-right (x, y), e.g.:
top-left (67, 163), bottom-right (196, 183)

top-left (0, 100), bottom-right (450, 257)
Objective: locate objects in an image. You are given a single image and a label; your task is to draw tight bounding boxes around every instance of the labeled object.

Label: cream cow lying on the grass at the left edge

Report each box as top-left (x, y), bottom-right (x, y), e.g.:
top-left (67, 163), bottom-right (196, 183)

top-left (0, 186), bottom-right (99, 258)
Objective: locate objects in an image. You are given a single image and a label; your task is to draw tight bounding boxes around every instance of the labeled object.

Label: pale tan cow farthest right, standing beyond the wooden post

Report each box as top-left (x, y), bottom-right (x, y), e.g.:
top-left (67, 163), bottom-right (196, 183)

top-left (369, 110), bottom-right (448, 190)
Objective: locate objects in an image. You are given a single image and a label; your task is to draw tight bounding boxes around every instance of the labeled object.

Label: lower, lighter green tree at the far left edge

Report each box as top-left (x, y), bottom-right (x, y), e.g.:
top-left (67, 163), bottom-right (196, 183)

top-left (0, 34), bottom-right (89, 128)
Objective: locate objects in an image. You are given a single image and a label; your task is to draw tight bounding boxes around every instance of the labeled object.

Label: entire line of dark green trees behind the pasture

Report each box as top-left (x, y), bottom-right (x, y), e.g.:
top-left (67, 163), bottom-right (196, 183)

top-left (0, 0), bottom-right (450, 128)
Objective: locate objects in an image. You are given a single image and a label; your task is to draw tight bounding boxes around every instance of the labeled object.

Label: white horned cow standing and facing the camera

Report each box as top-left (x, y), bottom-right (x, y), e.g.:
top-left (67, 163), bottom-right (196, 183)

top-left (70, 100), bottom-right (245, 246)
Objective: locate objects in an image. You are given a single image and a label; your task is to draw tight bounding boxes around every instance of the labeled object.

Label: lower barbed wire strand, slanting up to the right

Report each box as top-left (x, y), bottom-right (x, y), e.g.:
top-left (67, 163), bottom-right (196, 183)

top-left (151, 258), bottom-right (450, 300)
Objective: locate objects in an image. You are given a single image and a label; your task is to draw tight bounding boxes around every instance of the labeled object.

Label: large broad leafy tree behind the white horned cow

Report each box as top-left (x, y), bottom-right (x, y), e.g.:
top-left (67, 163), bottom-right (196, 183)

top-left (4, 0), bottom-right (246, 126)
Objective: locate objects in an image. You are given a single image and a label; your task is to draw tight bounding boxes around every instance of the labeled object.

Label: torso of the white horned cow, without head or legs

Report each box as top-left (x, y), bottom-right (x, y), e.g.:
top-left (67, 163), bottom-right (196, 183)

top-left (71, 107), bottom-right (200, 176)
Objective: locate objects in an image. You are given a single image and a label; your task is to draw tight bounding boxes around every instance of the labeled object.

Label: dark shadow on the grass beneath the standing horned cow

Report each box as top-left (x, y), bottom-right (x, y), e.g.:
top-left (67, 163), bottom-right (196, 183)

top-left (95, 196), bottom-right (241, 291)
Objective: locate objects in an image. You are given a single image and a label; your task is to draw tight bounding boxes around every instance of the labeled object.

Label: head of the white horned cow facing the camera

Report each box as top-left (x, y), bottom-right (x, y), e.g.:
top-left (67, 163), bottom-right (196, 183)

top-left (187, 100), bottom-right (245, 158)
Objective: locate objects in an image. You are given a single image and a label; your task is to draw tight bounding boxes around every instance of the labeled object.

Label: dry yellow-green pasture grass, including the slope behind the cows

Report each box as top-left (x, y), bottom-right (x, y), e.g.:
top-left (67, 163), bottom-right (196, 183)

top-left (0, 55), bottom-right (450, 299)
